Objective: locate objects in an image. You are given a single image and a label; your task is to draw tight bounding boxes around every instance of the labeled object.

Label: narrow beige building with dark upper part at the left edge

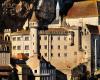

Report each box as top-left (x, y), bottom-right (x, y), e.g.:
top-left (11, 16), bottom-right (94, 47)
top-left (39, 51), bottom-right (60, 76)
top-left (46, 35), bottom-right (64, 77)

top-left (0, 35), bottom-right (12, 80)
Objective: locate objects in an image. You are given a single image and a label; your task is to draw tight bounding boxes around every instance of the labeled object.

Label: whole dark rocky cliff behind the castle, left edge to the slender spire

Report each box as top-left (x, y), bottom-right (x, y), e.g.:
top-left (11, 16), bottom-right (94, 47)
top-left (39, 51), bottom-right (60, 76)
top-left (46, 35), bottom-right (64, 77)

top-left (0, 0), bottom-right (72, 30)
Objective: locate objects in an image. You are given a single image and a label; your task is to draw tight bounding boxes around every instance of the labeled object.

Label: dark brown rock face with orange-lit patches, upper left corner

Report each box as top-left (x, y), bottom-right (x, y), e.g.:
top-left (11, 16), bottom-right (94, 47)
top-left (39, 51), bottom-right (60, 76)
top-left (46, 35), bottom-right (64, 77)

top-left (0, 0), bottom-right (34, 29)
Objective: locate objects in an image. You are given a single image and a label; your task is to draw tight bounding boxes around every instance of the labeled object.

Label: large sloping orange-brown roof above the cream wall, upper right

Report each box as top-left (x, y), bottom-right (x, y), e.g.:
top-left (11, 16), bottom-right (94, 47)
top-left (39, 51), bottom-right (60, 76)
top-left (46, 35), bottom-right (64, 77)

top-left (65, 1), bottom-right (99, 18)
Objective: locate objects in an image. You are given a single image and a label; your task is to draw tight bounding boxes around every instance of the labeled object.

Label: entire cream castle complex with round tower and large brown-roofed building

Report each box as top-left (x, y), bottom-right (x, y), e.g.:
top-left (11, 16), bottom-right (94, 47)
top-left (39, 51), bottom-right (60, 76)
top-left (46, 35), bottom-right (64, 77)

top-left (1, 1), bottom-right (100, 80)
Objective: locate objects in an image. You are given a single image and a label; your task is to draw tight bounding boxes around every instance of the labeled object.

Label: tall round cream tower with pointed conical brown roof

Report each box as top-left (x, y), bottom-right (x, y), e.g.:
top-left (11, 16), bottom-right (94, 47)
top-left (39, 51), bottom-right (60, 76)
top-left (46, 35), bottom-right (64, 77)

top-left (29, 12), bottom-right (38, 56)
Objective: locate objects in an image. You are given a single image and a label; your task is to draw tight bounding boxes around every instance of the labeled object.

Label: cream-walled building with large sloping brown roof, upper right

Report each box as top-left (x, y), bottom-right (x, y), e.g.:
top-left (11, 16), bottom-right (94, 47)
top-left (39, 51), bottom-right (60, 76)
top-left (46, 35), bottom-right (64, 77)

top-left (64, 1), bottom-right (100, 27)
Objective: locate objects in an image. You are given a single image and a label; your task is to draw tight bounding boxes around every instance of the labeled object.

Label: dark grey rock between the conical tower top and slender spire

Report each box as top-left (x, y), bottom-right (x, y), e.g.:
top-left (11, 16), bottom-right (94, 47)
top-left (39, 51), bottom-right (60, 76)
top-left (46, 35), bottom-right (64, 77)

top-left (36, 0), bottom-right (57, 24)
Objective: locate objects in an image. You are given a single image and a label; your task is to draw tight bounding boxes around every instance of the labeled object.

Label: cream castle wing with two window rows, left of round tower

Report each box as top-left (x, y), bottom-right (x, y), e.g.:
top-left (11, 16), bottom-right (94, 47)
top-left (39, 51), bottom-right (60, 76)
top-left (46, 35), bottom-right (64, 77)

top-left (11, 30), bottom-right (31, 56)
